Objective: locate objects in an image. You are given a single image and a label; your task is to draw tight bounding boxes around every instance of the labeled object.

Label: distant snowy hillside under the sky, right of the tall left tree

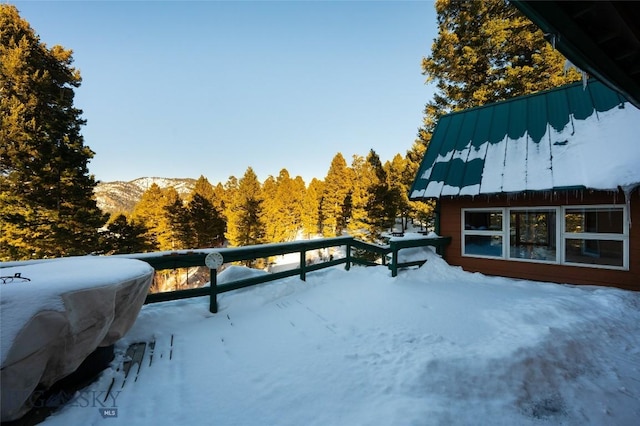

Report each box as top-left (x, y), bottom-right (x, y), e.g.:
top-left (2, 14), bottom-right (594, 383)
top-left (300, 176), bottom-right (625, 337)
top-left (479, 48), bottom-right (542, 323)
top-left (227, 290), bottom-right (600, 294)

top-left (94, 177), bottom-right (196, 213)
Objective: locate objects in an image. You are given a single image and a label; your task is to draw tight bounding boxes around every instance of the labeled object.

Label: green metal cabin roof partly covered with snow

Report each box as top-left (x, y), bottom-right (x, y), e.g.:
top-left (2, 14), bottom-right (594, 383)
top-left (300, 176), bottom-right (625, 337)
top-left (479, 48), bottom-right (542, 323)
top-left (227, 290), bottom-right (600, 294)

top-left (410, 81), bottom-right (640, 199)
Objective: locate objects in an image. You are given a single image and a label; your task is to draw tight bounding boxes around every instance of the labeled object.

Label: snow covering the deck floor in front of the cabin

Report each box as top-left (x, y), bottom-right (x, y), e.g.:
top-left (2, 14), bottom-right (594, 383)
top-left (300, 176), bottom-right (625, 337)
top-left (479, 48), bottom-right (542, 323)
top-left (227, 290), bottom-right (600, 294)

top-left (38, 252), bottom-right (640, 426)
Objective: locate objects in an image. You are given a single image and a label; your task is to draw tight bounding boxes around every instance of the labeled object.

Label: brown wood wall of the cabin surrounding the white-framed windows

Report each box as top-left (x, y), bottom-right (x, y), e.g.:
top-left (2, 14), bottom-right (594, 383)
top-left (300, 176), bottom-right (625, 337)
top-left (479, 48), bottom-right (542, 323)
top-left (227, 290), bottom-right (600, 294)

top-left (440, 189), bottom-right (640, 291)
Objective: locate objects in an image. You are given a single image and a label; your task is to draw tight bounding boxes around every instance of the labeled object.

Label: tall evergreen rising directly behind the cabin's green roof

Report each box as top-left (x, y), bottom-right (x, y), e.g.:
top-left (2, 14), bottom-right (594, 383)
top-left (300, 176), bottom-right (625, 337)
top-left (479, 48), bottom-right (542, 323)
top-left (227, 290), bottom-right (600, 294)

top-left (418, 0), bottom-right (580, 150)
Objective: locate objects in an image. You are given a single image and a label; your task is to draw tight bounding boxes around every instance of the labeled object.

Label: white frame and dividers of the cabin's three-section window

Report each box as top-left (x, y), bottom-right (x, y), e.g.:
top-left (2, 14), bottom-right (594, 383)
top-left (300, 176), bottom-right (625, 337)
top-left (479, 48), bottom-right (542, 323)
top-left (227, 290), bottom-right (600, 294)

top-left (460, 204), bottom-right (629, 271)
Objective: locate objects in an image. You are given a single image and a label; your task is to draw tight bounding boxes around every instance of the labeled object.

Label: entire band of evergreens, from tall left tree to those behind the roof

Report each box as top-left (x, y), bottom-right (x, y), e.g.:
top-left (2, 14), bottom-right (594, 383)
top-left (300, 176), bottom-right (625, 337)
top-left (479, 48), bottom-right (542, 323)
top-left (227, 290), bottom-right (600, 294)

top-left (0, 0), bottom-right (580, 261)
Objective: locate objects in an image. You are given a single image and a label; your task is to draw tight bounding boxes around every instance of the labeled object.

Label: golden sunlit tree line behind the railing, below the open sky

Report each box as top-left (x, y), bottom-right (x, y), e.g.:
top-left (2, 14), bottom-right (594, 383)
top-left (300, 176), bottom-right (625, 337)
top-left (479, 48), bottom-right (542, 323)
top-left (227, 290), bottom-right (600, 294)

top-left (101, 150), bottom-right (432, 253)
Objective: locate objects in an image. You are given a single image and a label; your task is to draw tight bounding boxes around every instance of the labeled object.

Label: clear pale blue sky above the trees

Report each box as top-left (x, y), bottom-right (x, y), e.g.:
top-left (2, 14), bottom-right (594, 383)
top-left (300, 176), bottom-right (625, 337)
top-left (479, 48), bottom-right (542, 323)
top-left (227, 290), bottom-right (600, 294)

top-left (9, 1), bottom-right (437, 184)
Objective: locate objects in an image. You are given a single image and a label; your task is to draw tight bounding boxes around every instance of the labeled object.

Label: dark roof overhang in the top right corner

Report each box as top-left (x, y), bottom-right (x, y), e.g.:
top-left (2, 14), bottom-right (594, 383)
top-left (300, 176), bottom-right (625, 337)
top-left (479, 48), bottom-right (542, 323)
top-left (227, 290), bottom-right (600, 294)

top-left (512, 0), bottom-right (640, 108)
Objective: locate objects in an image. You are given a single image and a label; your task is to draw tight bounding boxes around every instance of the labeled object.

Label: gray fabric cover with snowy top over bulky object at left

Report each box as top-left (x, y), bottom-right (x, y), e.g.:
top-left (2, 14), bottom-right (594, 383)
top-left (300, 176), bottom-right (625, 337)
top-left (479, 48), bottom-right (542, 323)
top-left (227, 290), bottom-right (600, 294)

top-left (0, 258), bottom-right (154, 422)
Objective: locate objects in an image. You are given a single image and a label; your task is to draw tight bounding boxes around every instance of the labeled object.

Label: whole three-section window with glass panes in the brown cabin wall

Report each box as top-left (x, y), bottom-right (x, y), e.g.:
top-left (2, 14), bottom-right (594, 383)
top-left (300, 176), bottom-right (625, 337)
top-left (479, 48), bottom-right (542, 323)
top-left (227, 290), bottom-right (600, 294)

top-left (462, 206), bottom-right (629, 269)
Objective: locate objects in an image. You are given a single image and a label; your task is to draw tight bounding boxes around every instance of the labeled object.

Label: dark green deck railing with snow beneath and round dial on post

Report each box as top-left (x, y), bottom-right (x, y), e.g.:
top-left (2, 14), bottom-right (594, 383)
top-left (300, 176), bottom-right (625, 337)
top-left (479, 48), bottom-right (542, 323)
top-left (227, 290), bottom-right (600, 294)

top-left (118, 237), bottom-right (451, 313)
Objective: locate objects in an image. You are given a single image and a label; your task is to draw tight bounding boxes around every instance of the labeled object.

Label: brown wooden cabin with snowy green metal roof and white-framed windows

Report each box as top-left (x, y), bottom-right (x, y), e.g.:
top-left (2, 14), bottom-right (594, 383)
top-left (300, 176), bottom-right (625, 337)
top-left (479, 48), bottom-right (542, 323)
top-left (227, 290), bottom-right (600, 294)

top-left (410, 81), bottom-right (640, 290)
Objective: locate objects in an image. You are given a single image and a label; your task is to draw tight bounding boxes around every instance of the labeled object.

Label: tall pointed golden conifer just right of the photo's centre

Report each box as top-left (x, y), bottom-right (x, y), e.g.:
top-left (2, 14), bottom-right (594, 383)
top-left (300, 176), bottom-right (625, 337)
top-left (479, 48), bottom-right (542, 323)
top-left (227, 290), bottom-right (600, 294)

top-left (320, 153), bottom-right (351, 237)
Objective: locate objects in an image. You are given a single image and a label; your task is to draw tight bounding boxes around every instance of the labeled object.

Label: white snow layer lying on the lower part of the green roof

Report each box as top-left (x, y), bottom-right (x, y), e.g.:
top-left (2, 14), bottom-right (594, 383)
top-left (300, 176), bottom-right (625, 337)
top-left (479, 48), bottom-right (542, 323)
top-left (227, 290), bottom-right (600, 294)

top-left (411, 94), bottom-right (640, 198)
